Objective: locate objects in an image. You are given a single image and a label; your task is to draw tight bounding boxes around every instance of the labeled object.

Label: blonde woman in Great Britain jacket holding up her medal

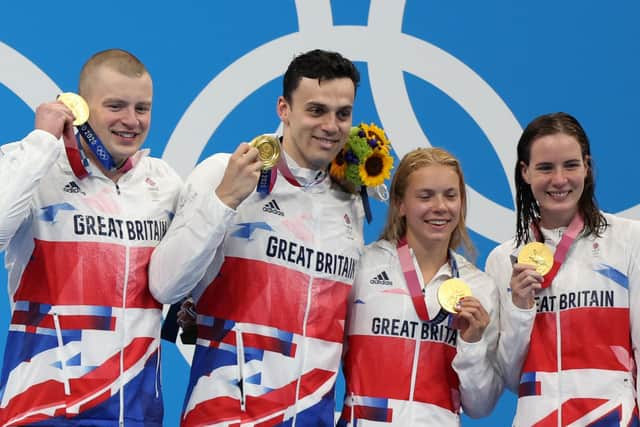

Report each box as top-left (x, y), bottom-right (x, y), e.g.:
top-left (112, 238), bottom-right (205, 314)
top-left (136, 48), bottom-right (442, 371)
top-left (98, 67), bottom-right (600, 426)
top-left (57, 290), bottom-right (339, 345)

top-left (338, 148), bottom-right (502, 427)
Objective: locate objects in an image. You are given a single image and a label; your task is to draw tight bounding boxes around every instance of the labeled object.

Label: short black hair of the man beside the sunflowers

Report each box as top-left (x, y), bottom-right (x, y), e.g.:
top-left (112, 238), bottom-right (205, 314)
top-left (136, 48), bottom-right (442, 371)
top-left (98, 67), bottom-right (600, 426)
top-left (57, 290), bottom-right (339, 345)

top-left (282, 49), bottom-right (360, 103)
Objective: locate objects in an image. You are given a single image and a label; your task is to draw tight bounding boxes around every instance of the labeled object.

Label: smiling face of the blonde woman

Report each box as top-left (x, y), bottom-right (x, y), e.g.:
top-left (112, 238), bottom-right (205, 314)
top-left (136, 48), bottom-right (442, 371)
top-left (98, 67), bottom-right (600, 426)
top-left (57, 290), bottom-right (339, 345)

top-left (398, 164), bottom-right (462, 253)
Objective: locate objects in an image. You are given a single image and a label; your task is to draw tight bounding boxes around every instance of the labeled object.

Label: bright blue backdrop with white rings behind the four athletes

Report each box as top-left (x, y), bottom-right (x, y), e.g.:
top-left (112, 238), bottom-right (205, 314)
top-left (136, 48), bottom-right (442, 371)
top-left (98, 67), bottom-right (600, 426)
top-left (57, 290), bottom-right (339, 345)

top-left (0, 0), bottom-right (640, 426)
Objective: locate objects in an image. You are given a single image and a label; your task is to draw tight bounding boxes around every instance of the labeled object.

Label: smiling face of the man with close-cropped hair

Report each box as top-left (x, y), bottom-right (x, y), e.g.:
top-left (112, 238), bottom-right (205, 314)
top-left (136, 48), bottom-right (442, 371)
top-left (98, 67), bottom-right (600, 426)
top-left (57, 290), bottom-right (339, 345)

top-left (82, 66), bottom-right (153, 168)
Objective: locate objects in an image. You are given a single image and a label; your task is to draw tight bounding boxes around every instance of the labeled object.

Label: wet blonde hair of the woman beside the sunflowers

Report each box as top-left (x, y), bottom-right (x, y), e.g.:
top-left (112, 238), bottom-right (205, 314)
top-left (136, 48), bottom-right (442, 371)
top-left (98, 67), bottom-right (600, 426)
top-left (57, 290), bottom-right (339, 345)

top-left (380, 147), bottom-right (475, 257)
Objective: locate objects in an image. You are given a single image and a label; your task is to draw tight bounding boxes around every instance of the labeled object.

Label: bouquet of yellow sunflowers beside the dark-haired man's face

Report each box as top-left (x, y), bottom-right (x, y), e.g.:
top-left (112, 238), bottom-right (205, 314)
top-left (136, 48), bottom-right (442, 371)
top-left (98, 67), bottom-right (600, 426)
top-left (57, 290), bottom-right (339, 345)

top-left (329, 123), bottom-right (393, 192)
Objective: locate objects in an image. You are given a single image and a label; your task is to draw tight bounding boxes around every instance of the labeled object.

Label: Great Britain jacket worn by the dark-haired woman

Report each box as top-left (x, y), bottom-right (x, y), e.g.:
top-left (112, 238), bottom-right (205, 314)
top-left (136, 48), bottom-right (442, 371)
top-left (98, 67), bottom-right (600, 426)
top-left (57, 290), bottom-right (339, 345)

top-left (487, 215), bottom-right (640, 426)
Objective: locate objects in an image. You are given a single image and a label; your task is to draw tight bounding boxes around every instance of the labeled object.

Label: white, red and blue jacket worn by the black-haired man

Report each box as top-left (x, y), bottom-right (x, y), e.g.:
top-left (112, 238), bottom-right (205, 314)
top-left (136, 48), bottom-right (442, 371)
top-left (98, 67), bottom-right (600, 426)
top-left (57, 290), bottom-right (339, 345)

top-left (150, 155), bottom-right (363, 427)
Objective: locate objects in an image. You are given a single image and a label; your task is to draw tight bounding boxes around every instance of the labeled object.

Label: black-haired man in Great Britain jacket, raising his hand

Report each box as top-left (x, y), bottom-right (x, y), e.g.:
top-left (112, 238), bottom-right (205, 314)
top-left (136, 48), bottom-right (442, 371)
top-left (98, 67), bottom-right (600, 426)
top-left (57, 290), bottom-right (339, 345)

top-left (150, 50), bottom-right (363, 426)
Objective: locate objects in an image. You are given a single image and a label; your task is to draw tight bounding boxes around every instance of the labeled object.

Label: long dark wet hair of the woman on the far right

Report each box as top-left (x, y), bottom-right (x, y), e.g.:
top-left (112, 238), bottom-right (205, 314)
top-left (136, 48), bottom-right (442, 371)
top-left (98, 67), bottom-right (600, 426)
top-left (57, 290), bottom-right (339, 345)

top-left (514, 112), bottom-right (607, 245)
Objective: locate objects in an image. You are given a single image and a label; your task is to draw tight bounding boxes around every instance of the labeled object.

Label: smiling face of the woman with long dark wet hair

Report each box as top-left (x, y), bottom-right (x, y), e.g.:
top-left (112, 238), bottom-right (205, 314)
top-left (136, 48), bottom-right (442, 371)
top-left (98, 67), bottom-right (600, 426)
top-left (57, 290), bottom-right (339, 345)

top-left (521, 133), bottom-right (588, 228)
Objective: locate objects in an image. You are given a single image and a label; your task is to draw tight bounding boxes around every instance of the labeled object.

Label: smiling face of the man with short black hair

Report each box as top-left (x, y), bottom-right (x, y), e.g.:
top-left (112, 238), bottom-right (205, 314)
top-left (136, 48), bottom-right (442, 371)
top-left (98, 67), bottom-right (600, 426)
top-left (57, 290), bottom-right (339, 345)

top-left (277, 77), bottom-right (355, 169)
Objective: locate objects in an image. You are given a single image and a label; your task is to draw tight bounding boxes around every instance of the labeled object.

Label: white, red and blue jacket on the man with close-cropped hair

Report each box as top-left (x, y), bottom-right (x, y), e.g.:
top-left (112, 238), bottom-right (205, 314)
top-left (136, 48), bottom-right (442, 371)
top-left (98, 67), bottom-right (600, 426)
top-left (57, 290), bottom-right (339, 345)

top-left (0, 130), bottom-right (181, 427)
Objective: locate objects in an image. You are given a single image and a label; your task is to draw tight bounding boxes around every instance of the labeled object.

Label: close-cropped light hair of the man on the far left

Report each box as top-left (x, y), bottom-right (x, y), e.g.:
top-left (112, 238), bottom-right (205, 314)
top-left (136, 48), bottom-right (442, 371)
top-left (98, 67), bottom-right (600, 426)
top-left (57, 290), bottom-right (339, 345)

top-left (78, 49), bottom-right (149, 96)
